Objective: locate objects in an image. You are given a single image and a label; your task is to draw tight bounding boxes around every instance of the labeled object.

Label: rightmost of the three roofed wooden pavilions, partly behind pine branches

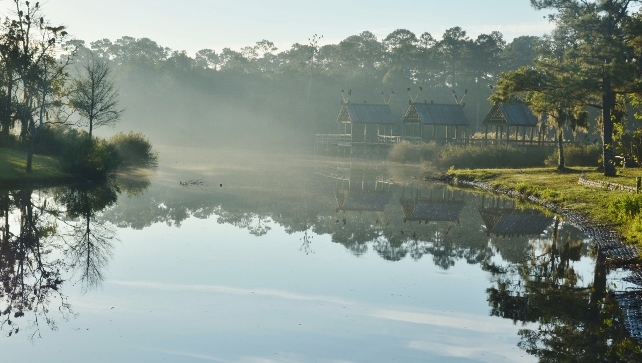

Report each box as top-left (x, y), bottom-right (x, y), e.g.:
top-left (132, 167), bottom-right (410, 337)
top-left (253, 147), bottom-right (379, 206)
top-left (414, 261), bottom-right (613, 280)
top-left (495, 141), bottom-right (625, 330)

top-left (483, 102), bottom-right (542, 144)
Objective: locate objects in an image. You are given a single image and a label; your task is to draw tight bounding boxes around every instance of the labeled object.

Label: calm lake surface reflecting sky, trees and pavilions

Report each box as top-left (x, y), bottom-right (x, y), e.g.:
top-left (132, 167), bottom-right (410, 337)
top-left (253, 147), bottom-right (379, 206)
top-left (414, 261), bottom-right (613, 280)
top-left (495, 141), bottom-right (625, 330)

top-left (0, 148), bottom-right (640, 362)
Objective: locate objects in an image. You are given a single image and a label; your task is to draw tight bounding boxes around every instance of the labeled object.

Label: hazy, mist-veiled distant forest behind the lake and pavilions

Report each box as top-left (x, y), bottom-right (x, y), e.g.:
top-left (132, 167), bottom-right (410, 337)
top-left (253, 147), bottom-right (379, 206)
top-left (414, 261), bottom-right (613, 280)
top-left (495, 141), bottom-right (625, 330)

top-left (79, 27), bottom-right (537, 151)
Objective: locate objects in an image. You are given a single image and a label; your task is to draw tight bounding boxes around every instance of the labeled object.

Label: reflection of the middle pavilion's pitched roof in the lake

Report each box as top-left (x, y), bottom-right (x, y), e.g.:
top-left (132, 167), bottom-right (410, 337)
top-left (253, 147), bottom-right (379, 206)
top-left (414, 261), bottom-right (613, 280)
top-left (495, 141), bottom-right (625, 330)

top-left (399, 198), bottom-right (464, 222)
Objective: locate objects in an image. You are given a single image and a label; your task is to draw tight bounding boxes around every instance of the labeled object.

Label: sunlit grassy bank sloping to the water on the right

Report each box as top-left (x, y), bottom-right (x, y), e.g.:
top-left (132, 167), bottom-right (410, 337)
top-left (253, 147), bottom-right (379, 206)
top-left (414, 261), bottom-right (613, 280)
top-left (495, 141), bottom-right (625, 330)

top-left (440, 167), bottom-right (642, 258)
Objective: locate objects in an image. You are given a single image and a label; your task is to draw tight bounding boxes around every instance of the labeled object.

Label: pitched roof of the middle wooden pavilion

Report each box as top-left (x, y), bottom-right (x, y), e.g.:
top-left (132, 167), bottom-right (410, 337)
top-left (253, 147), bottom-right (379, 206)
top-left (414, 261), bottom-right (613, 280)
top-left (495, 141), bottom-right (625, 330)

top-left (403, 103), bottom-right (468, 126)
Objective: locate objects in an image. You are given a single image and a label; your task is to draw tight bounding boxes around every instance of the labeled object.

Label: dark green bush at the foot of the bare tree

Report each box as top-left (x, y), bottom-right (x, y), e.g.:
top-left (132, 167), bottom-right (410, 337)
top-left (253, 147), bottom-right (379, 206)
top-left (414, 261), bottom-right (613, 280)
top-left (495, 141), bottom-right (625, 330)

top-left (61, 132), bottom-right (121, 179)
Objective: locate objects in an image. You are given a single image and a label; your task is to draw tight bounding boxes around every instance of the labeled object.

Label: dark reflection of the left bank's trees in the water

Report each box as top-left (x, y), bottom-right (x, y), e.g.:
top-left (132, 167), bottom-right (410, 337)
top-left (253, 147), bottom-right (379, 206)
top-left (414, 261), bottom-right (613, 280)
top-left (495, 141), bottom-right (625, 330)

top-left (0, 173), bottom-right (149, 339)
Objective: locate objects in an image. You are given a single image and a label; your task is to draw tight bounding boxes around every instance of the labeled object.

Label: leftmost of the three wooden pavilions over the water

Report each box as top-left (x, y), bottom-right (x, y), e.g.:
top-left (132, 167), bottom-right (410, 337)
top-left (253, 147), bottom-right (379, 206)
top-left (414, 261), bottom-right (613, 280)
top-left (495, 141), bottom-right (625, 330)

top-left (337, 102), bottom-right (399, 144)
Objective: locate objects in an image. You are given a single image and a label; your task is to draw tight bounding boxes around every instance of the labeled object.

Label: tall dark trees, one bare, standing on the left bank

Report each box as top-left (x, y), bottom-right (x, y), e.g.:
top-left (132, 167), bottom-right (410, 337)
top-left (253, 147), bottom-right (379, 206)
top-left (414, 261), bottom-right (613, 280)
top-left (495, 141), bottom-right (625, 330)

top-left (0, 0), bottom-right (133, 174)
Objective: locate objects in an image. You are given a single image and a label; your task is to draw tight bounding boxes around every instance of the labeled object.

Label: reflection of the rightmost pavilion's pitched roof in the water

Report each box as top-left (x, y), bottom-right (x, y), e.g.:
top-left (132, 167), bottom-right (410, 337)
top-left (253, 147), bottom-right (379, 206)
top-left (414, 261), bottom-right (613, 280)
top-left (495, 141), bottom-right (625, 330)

top-left (479, 208), bottom-right (552, 235)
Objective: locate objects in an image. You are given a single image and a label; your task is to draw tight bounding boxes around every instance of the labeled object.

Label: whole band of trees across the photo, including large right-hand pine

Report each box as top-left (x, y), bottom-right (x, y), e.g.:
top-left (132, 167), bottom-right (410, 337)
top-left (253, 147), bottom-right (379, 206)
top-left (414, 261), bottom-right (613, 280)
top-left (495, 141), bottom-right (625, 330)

top-left (0, 0), bottom-right (642, 175)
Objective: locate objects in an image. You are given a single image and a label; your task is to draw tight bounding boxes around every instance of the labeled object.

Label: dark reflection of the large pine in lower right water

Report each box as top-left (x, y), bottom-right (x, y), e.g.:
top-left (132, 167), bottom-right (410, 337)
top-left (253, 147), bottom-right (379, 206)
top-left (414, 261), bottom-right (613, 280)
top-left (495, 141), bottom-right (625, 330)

top-left (484, 218), bottom-right (642, 362)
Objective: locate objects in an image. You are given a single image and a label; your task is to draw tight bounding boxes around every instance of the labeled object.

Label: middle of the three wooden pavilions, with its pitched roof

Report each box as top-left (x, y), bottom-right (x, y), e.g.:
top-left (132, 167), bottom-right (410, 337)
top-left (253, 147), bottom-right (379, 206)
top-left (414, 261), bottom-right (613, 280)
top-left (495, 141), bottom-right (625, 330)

top-left (402, 102), bottom-right (469, 142)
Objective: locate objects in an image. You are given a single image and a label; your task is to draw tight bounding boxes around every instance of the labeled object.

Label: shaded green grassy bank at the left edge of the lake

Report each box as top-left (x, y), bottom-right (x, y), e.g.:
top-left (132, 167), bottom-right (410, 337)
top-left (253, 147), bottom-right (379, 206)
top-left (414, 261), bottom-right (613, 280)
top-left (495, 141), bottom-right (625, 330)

top-left (0, 148), bottom-right (73, 187)
